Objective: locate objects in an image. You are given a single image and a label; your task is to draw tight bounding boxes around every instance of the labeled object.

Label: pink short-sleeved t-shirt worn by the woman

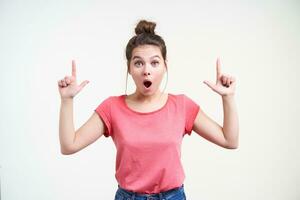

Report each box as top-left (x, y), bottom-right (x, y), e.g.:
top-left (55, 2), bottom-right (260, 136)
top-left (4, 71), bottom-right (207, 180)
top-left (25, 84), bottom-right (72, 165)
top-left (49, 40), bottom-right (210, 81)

top-left (95, 94), bottom-right (200, 194)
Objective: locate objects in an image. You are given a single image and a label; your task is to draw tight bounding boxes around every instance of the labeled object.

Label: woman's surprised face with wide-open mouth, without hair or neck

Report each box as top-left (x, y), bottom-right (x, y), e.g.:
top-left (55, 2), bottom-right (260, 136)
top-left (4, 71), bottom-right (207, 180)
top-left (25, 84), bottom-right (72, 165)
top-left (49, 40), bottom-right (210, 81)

top-left (129, 45), bottom-right (167, 96)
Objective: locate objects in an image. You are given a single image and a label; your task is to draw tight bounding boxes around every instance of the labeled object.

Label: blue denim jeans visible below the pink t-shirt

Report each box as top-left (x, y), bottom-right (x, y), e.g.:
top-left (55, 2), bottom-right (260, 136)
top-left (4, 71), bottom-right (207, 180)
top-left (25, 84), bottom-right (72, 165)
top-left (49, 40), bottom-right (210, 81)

top-left (115, 184), bottom-right (186, 200)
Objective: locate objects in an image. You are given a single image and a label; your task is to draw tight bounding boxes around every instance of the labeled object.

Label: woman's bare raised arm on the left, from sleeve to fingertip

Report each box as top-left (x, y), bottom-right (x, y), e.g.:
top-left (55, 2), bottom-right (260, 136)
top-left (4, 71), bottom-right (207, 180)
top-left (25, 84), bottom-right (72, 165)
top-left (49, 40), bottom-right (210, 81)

top-left (58, 61), bottom-right (104, 155)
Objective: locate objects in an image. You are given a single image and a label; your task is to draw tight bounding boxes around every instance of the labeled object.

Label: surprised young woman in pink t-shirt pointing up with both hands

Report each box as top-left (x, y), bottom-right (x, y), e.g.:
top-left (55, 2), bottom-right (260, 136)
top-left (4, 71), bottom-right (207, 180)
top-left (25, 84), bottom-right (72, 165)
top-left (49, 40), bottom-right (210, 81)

top-left (58, 20), bottom-right (239, 200)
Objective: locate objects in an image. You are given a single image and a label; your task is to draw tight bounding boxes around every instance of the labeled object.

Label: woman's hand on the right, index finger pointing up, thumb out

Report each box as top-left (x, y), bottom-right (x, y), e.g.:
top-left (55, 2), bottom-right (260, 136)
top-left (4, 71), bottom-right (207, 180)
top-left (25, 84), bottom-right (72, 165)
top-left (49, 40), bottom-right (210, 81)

top-left (203, 58), bottom-right (236, 96)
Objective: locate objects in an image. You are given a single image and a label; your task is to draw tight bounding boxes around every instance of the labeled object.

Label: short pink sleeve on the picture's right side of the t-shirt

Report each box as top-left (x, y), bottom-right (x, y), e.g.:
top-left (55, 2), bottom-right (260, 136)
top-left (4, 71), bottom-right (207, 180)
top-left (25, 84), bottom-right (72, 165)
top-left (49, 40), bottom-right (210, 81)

top-left (183, 95), bottom-right (200, 135)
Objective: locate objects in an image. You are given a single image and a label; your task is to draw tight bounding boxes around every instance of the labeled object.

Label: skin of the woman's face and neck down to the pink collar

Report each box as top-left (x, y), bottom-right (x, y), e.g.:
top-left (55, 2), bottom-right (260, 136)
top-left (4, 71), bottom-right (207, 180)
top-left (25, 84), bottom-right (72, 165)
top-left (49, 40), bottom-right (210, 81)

top-left (126, 45), bottom-right (167, 112)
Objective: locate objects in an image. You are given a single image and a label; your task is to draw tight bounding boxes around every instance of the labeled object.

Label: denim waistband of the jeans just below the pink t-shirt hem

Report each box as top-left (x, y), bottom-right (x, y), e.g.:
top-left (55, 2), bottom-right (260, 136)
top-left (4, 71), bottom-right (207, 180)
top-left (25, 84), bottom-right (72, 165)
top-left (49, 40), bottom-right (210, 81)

top-left (118, 184), bottom-right (184, 199)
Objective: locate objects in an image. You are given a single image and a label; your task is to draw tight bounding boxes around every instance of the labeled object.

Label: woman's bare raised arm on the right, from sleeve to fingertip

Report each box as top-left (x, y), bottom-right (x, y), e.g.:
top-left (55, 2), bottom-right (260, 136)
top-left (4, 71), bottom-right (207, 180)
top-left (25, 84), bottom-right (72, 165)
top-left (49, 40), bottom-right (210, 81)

top-left (193, 59), bottom-right (239, 149)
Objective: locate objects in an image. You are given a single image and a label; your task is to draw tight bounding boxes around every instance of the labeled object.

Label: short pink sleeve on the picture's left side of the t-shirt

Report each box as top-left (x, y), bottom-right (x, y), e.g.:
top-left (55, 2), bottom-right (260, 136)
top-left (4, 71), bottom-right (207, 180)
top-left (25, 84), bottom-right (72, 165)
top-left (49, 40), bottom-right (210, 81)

top-left (94, 97), bottom-right (113, 137)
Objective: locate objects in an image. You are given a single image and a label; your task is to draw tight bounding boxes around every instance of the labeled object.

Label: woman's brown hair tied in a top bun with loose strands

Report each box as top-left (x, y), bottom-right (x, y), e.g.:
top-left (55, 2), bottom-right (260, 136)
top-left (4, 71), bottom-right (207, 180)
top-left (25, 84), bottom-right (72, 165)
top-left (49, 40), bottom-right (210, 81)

top-left (125, 20), bottom-right (168, 93)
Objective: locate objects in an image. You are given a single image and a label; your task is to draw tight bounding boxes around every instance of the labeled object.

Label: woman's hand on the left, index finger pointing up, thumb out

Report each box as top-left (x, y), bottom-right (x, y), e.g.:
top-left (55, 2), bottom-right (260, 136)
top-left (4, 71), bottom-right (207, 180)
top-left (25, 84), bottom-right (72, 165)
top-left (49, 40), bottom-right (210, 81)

top-left (58, 60), bottom-right (89, 99)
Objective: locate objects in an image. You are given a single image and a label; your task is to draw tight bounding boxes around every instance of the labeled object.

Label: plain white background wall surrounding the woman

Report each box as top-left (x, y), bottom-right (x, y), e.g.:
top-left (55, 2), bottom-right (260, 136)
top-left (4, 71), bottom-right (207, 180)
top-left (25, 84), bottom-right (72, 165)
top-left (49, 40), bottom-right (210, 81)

top-left (0, 0), bottom-right (300, 200)
